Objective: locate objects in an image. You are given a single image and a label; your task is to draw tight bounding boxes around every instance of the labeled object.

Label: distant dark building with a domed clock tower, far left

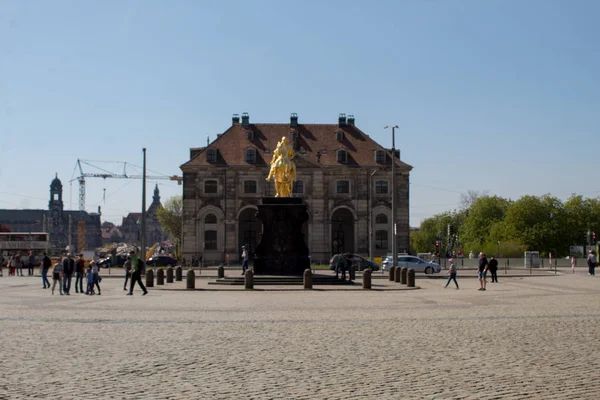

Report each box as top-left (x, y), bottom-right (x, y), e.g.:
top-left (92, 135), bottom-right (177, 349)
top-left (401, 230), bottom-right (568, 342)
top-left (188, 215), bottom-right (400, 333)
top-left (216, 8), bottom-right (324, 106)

top-left (0, 175), bottom-right (102, 254)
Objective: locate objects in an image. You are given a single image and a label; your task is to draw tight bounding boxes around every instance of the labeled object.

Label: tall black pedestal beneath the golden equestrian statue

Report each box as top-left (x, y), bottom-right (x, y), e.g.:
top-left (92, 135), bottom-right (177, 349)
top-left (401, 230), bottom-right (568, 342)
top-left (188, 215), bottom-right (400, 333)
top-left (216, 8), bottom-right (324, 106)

top-left (254, 197), bottom-right (310, 275)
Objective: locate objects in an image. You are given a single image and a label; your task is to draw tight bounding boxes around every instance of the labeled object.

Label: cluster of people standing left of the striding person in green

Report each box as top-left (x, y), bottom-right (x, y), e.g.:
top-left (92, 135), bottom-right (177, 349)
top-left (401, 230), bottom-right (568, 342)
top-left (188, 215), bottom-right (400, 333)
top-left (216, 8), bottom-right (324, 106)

top-left (42, 253), bottom-right (102, 296)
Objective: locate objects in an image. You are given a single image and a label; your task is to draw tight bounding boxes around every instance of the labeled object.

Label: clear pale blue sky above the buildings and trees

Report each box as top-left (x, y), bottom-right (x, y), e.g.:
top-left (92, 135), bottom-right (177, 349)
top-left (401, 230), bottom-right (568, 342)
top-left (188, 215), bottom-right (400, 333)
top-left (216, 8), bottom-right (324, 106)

top-left (0, 0), bottom-right (600, 226)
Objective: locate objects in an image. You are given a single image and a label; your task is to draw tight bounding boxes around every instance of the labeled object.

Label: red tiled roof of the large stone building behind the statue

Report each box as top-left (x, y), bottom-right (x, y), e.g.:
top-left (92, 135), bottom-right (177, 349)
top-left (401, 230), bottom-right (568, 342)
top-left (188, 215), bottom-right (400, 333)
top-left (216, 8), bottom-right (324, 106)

top-left (181, 118), bottom-right (412, 170)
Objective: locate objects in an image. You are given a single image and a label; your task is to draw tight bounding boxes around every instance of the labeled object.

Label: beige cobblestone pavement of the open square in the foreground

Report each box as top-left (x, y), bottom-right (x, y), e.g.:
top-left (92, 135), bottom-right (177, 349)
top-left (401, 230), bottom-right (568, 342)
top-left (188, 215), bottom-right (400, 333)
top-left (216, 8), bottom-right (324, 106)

top-left (0, 274), bottom-right (600, 400)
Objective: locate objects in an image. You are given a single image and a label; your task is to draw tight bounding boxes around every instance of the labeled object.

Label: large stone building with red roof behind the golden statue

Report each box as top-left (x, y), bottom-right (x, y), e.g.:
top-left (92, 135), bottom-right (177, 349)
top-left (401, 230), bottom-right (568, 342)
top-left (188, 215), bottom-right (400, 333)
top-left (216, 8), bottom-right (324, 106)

top-left (180, 113), bottom-right (412, 263)
